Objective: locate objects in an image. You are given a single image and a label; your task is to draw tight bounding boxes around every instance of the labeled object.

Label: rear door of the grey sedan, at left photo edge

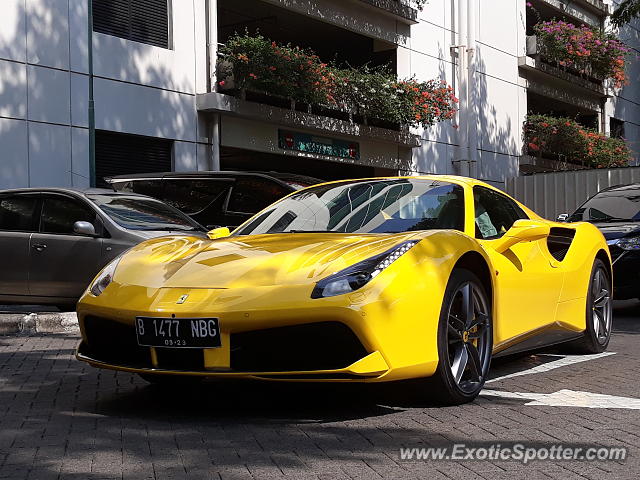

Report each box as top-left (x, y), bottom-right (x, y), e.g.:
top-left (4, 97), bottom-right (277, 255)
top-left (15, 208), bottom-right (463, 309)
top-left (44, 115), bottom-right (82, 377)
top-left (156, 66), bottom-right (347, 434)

top-left (0, 194), bottom-right (38, 297)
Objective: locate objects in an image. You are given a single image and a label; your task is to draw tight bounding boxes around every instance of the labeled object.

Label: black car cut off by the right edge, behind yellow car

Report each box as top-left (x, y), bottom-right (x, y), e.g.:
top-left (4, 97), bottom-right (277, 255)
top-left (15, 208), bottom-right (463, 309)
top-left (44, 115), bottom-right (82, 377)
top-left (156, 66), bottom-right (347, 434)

top-left (558, 183), bottom-right (640, 300)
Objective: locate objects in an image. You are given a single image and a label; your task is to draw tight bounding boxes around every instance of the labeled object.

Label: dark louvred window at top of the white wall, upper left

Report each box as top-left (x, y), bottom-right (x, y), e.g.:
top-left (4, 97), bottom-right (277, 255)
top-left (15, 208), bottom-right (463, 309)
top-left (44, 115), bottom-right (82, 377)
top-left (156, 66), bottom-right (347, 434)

top-left (93, 0), bottom-right (171, 48)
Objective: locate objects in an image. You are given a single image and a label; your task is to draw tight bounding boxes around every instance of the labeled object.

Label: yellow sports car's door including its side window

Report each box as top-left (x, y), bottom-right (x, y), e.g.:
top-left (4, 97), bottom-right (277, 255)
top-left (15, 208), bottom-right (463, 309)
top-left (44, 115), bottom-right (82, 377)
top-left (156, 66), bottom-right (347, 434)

top-left (473, 186), bottom-right (564, 345)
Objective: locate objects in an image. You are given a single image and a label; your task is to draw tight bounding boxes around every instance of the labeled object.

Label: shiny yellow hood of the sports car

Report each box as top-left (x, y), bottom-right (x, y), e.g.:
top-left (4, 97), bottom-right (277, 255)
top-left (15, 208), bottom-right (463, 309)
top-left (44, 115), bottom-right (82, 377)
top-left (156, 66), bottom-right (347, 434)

top-left (114, 232), bottom-right (419, 288)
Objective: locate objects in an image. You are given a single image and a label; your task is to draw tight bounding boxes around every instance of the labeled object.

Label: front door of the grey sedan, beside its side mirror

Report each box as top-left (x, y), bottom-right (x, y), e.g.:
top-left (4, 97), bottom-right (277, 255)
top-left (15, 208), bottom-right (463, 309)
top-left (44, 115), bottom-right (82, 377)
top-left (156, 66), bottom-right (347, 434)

top-left (29, 194), bottom-right (102, 299)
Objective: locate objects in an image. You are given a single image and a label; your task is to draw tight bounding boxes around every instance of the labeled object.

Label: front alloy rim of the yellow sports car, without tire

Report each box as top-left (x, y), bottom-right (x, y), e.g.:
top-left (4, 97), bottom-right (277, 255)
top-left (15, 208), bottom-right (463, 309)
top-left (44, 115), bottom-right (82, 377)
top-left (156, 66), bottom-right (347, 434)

top-left (447, 281), bottom-right (492, 393)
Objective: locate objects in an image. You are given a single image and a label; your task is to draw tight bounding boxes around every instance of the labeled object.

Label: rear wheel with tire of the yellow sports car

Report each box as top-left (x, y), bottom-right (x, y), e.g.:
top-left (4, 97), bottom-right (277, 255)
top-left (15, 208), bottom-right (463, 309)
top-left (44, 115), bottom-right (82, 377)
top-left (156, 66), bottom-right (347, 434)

top-left (569, 258), bottom-right (613, 354)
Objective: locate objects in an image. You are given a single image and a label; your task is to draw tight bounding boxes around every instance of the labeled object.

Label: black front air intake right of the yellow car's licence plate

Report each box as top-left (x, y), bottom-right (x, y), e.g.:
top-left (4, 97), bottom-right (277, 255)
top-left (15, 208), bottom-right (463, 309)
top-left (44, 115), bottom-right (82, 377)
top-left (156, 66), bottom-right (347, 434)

top-left (231, 322), bottom-right (367, 372)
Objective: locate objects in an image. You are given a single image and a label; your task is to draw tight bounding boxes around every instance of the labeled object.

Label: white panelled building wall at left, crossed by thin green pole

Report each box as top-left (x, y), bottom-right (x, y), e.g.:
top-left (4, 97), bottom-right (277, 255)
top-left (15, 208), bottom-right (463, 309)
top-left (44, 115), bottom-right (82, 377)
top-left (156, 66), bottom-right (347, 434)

top-left (0, 0), bottom-right (206, 188)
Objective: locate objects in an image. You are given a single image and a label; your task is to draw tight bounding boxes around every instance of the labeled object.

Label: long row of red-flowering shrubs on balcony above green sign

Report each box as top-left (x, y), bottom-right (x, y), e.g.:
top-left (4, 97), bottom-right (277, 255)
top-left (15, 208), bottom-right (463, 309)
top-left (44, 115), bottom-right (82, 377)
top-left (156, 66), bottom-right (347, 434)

top-left (218, 34), bottom-right (458, 127)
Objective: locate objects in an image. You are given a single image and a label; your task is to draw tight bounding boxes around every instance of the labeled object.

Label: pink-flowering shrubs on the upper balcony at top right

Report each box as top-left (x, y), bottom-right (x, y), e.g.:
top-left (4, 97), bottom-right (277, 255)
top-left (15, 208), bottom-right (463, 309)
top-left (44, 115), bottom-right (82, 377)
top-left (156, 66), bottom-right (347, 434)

top-left (534, 20), bottom-right (630, 87)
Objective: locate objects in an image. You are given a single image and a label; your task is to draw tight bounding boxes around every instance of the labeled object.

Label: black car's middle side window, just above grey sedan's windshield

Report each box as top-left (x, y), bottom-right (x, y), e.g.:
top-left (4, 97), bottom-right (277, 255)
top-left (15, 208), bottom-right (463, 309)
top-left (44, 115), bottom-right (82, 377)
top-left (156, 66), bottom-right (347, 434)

top-left (162, 179), bottom-right (231, 215)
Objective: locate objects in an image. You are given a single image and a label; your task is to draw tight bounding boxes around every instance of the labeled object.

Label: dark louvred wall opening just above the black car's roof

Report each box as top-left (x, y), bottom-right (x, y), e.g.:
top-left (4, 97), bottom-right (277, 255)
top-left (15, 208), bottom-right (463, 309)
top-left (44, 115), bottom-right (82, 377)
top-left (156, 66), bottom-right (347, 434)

top-left (96, 130), bottom-right (173, 187)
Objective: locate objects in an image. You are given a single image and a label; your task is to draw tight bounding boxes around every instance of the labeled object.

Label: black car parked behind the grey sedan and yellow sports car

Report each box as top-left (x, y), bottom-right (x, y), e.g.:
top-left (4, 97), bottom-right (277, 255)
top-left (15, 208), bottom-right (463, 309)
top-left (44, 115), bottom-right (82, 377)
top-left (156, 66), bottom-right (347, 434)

top-left (105, 171), bottom-right (323, 228)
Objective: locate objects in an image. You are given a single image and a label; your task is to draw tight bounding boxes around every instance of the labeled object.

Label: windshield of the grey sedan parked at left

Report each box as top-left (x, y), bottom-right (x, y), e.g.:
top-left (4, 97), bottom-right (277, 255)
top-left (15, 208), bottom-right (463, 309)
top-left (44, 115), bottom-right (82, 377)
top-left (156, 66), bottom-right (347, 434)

top-left (89, 195), bottom-right (204, 231)
